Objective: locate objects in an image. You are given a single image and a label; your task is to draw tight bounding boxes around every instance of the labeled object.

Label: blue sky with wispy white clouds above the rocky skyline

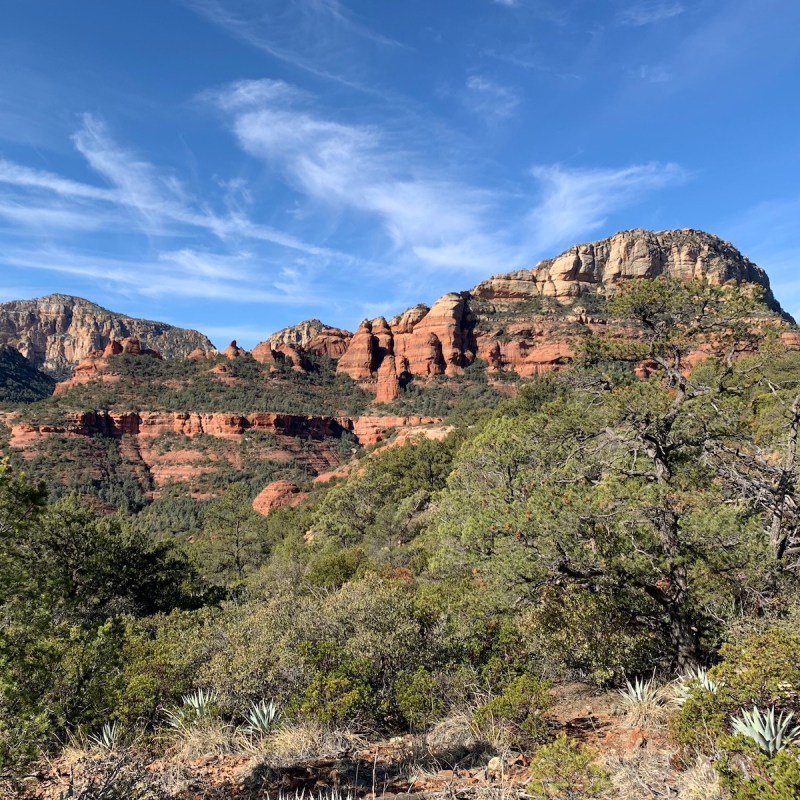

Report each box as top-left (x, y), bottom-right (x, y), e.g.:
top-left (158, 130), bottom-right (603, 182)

top-left (0, 0), bottom-right (800, 346)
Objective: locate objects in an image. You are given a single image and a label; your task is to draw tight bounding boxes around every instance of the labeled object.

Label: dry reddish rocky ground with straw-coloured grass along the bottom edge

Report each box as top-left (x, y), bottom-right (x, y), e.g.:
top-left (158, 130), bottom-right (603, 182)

top-left (9, 684), bottom-right (724, 800)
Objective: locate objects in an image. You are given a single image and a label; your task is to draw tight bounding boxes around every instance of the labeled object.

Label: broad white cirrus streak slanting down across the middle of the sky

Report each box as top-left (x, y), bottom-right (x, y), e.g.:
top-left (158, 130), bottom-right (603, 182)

top-left (206, 81), bottom-right (500, 266)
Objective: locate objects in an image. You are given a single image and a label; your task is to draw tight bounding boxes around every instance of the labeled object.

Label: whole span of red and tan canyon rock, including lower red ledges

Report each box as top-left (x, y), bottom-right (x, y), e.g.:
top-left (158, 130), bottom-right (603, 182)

top-left (0, 229), bottom-right (800, 513)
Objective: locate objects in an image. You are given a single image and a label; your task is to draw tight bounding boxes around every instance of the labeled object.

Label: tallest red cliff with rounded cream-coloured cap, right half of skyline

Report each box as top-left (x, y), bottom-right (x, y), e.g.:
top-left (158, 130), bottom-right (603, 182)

top-left (330, 230), bottom-right (788, 402)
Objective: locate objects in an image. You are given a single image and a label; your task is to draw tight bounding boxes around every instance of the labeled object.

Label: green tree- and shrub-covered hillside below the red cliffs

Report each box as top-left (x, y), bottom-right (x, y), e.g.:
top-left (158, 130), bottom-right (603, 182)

top-left (0, 277), bottom-right (800, 800)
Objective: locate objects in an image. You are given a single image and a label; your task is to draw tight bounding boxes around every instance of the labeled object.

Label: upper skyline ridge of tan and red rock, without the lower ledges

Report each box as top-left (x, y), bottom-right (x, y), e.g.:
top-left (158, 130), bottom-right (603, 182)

top-left (6, 229), bottom-right (788, 402)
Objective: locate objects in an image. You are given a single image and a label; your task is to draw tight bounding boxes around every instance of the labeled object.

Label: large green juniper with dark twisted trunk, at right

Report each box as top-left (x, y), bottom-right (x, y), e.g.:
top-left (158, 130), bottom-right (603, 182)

top-left (434, 279), bottom-right (788, 669)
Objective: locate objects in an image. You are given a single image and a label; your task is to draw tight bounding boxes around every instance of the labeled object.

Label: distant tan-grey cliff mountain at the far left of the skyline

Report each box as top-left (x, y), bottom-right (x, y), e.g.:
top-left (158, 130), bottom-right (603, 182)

top-left (0, 294), bottom-right (213, 377)
